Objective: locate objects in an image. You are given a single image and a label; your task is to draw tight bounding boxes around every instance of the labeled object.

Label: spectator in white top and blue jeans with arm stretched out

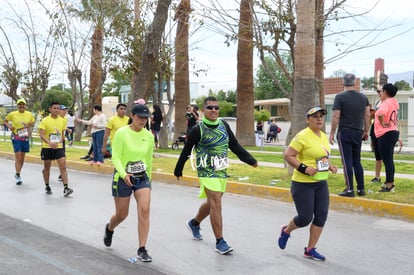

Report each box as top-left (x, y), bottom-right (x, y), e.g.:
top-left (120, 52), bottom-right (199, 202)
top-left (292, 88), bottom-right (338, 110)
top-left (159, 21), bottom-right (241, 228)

top-left (77, 104), bottom-right (106, 165)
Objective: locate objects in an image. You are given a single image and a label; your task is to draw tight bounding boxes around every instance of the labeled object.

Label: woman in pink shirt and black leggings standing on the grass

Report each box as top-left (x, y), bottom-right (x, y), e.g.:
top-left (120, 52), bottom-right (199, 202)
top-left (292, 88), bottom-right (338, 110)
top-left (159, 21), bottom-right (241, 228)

top-left (374, 83), bottom-right (400, 192)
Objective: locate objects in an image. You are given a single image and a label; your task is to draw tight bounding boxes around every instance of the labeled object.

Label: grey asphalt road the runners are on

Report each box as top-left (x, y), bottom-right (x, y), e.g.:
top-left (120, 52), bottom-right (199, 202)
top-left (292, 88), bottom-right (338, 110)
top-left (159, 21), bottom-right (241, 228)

top-left (0, 159), bottom-right (414, 275)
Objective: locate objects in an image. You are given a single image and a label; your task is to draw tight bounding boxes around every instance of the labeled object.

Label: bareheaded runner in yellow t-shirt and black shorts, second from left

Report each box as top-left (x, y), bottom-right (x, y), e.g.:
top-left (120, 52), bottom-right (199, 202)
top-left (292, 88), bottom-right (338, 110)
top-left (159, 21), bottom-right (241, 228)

top-left (39, 102), bottom-right (73, 197)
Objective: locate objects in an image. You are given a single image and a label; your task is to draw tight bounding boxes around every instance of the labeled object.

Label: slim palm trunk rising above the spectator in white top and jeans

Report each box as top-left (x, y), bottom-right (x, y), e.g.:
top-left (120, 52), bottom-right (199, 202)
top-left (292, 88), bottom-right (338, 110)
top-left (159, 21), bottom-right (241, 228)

top-left (88, 25), bottom-right (105, 117)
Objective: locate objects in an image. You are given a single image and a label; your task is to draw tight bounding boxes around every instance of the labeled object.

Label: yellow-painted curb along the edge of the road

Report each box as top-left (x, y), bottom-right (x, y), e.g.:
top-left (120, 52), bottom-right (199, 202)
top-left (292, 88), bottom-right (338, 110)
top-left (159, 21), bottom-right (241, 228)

top-left (0, 152), bottom-right (414, 221)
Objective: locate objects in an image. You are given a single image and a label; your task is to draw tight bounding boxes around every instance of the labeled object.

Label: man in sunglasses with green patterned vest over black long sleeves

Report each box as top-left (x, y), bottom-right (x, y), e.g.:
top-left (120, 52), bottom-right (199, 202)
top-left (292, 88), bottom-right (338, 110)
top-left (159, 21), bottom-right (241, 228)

top-left (174, 96), bottom-right (257, 255)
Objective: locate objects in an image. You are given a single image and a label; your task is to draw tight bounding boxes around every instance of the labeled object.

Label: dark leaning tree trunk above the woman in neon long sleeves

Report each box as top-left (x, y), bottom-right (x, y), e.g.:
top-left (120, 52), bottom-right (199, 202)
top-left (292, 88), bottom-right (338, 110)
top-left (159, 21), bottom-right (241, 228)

top-left (128, 0), bottom-right (171, 110)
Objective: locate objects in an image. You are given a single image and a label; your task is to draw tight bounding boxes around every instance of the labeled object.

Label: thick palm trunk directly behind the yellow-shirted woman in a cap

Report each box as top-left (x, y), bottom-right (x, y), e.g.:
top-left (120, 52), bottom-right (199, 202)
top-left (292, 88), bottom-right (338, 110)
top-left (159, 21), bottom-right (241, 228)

top-left (291, 0), bottom-right (319, 136)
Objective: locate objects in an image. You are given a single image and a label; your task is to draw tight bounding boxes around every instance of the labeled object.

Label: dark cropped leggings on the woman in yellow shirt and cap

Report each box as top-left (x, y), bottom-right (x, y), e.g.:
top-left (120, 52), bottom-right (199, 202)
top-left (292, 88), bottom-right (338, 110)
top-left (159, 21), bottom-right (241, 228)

top-left (290, 180), bottom-right (329, 227)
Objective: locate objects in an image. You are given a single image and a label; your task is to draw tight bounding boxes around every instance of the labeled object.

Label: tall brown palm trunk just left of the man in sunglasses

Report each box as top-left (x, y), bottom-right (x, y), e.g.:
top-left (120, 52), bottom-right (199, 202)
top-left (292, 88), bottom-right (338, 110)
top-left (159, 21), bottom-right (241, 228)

top-left (173, 0), bottom-right (191, 140)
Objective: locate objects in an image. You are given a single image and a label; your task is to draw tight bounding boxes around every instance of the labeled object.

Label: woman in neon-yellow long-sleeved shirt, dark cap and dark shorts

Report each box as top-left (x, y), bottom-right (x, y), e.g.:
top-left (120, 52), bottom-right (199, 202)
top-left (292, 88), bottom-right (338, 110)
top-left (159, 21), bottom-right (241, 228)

top-left (103, 104), bottom-right (154, 262)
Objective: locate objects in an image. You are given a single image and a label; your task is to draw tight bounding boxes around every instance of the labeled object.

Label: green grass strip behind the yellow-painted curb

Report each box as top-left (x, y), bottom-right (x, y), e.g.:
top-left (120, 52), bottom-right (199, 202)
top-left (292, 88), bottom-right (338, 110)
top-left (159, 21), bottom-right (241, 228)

top-left (0, 139), bottom-right (414, 204)
